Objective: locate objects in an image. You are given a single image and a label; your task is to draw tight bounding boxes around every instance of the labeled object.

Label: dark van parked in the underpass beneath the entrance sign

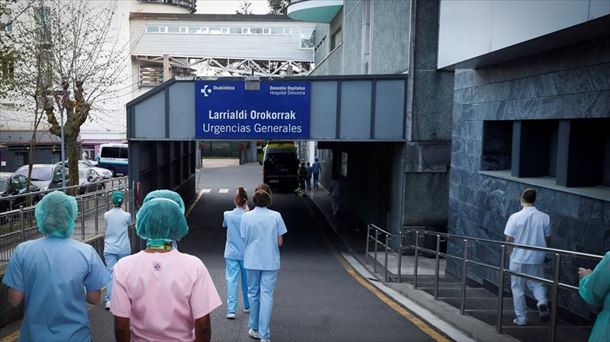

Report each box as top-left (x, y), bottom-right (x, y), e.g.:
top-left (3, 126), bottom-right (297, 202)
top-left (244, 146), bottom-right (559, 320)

top-left (263, 141), bottom-right (299, 190)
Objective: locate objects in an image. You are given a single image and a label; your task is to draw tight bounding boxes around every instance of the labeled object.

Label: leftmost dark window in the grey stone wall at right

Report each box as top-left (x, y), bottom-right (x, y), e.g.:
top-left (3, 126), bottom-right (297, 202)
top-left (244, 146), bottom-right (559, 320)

top-left (481, 121), bottom-right (513, 170)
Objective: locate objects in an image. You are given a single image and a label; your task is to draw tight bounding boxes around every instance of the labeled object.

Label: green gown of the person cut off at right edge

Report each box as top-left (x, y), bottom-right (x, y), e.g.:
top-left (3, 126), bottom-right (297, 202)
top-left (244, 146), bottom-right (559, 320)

top-left (579, 252), bottom-right (610, 342)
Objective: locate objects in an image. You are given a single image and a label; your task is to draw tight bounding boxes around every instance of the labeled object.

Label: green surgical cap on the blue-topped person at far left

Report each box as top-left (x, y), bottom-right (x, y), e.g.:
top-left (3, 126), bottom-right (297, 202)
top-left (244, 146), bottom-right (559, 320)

top-left (34, 191), bottom-right (78, 238)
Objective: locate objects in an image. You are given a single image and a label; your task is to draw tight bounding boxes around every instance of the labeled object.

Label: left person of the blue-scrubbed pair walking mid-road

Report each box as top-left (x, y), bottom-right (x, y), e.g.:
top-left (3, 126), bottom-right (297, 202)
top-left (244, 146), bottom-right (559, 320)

top-left (222, 188), bottom-right (250, 319)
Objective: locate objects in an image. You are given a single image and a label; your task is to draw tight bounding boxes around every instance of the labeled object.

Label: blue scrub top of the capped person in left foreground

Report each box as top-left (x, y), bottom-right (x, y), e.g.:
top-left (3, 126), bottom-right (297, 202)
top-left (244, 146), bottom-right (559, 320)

top-left (2, 237), bottom-right (110, 341)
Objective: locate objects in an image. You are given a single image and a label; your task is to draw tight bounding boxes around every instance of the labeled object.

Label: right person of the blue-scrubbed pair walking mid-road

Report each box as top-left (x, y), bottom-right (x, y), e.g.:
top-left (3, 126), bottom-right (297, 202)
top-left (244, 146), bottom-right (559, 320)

top-left (240, 185), bottom-right (287, 342)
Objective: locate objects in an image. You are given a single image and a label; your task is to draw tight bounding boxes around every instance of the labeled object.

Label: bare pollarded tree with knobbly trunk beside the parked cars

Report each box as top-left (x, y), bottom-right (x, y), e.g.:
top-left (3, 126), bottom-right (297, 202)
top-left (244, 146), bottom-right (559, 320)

top-left (5, 0), bottom-right (127, 185)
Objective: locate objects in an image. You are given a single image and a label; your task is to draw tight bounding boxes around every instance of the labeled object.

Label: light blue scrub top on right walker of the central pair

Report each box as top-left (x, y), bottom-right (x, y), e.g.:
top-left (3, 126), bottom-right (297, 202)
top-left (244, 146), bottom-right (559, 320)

top-left (240, 207), bottom-right (287, 271)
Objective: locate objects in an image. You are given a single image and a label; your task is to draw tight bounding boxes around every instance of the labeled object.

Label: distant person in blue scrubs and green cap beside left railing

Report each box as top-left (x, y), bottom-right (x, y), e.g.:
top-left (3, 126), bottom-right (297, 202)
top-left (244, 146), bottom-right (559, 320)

top-left (104, 191), bottom-right (131, 310)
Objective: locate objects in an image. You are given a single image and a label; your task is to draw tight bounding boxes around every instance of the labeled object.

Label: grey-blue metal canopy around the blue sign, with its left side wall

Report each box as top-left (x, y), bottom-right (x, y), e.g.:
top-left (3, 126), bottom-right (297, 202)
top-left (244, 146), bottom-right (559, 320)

top-left (127, 75), bottom-right (407, 200)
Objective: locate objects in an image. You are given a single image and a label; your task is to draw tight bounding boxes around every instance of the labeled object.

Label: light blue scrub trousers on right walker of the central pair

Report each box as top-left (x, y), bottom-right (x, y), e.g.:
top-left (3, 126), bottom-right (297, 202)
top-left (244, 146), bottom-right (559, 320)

top-left (247, 270), bottom-right (278, 339)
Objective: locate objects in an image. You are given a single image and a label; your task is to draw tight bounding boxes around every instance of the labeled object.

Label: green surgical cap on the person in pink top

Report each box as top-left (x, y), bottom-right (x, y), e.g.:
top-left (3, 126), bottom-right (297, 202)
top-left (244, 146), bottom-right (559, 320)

top-left (136, 198), bottom-right (189, 241)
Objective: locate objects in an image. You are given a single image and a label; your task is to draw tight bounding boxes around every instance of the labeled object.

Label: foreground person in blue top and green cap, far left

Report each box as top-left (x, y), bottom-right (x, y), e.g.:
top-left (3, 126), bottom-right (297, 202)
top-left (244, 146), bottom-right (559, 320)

top-left (2, 191), bottom-right (109, 341)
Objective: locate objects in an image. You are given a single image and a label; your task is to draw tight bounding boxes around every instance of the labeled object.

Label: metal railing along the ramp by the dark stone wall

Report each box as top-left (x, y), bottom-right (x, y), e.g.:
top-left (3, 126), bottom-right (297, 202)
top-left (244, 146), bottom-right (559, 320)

top-left (365, 224), bottom-right (603, 342)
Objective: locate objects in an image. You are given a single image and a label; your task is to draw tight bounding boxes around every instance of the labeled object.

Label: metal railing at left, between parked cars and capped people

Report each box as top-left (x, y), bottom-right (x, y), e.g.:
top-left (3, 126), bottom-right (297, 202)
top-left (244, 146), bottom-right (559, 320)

top-left (0, 177), bottom-right (135, 273)
